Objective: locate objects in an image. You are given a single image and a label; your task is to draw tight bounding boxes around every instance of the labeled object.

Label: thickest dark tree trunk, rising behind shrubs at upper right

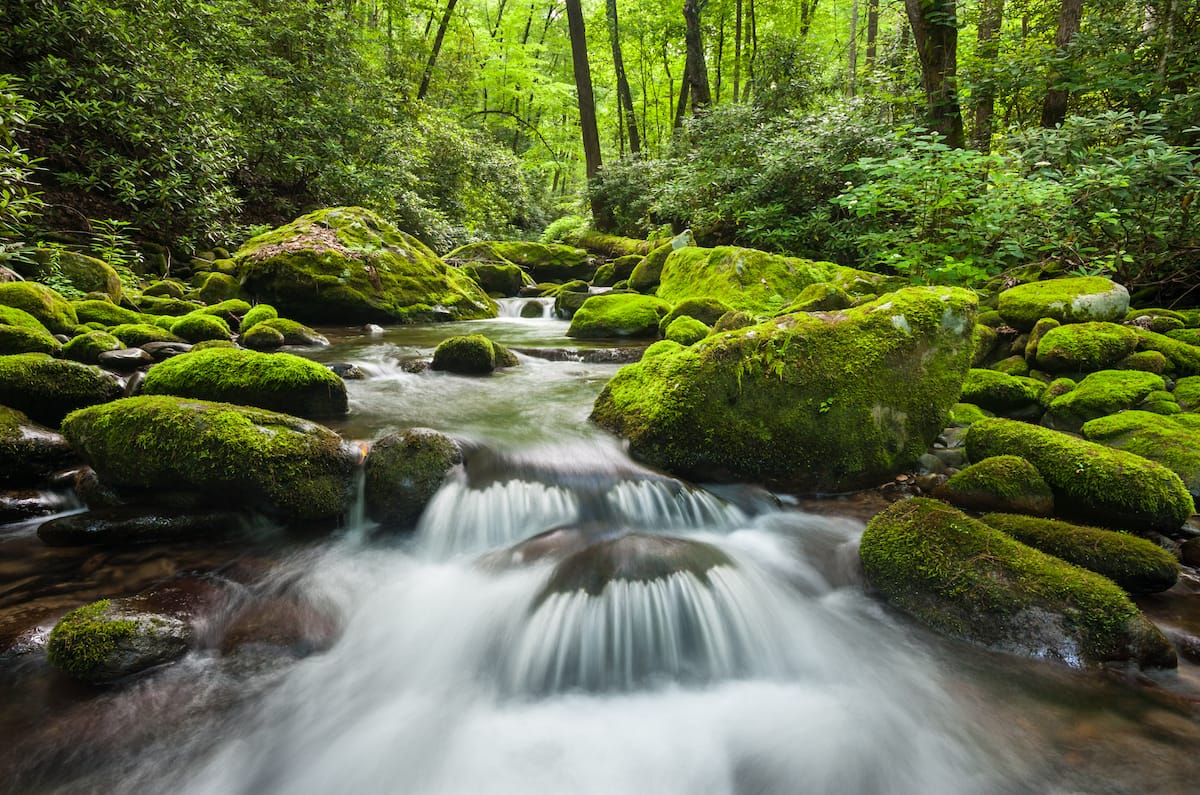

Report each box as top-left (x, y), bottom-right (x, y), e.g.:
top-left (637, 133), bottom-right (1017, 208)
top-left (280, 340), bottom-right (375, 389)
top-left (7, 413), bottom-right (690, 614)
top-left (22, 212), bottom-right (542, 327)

top-left (904, 0), bottom-right (962, 149)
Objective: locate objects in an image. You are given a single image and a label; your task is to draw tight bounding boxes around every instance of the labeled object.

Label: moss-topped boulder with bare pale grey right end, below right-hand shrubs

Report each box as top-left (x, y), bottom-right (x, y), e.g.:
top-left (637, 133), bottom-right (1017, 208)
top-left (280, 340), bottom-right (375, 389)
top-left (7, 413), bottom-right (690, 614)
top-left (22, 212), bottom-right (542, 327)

top-left (998, 276), bottom-right (1129, 331)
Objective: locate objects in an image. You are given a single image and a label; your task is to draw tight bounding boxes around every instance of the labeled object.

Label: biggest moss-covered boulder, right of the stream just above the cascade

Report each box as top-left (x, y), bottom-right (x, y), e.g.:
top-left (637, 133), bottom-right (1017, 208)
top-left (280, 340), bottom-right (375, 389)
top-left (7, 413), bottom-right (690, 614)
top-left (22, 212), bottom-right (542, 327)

top-left (592, 287), bottom-right (976, 492)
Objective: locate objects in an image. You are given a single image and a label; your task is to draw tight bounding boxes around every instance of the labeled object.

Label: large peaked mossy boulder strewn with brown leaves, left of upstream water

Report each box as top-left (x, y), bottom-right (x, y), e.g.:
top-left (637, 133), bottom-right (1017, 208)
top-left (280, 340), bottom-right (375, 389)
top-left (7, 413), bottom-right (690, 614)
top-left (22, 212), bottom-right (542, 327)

top-left (236, 207), bottom-right (496, 324)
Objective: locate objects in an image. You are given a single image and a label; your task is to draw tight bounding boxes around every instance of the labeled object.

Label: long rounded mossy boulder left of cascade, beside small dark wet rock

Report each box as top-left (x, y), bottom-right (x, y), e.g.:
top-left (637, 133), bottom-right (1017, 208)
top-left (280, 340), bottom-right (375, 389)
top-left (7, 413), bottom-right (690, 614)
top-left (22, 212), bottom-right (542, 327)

top-left (62, 396), bottom-right (355, 520)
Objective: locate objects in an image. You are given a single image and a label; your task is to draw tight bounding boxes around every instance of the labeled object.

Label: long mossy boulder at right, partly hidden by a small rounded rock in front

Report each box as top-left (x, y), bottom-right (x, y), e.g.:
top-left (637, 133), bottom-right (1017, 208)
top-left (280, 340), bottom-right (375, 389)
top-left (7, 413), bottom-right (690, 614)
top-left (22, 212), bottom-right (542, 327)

top-left (966, 418), bottom-right (1195, 532)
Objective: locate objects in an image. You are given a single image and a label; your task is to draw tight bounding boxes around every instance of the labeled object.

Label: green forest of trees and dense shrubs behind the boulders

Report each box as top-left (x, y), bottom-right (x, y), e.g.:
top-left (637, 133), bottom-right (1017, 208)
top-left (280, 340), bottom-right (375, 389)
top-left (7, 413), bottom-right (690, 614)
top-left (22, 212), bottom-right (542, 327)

top-left (0, 0), bottom-right (1200, 304)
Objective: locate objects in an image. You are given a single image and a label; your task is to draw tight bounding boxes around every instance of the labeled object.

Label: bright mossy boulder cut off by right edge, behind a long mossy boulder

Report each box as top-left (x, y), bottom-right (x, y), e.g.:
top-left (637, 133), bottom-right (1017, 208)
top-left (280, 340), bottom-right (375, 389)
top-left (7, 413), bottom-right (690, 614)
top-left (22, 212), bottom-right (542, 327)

top-left (1081, 411), bottom-right (1200, 500)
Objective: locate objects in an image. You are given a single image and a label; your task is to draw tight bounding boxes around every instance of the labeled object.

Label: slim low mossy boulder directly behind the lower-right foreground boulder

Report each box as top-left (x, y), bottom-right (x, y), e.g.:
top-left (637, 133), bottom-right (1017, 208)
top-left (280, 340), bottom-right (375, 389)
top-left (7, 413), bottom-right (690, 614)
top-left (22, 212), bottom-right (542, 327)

top-left (982, 513), bottom-right (1180, 593)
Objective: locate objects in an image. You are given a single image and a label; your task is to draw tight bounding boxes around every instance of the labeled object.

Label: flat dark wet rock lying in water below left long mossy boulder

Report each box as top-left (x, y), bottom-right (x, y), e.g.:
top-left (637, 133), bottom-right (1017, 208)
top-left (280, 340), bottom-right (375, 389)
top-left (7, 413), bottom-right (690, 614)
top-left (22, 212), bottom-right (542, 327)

top-left (37, 506), bottom-right (246, 546)
